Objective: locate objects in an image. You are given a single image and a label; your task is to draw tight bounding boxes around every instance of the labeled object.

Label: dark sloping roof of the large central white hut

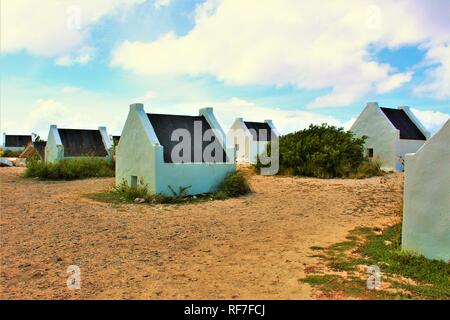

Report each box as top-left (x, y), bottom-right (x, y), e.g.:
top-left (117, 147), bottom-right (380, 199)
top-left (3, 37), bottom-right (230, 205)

top-left (147, 113), bottom-right (228, 163)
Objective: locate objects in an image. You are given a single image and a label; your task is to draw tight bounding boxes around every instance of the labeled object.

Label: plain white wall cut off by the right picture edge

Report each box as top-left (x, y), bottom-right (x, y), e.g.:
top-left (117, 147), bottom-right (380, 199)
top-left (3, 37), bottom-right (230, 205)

top-left (402, 120), bottom-right (450, 261)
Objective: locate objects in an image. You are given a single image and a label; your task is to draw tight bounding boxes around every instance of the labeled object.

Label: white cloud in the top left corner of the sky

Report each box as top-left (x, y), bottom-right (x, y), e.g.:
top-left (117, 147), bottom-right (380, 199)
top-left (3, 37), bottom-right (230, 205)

top-left (0, 0), bottom-right (143, 56)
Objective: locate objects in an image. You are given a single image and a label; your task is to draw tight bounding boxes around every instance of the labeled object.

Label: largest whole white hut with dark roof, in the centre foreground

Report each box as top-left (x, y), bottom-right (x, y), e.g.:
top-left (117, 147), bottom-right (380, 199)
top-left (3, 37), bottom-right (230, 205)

top-left (116, 104), bottom-right (236, 195)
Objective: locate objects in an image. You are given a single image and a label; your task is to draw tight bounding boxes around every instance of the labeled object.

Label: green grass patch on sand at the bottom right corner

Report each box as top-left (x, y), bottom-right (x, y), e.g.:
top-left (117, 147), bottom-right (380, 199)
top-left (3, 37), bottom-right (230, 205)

top-left (305, 224), bottom-right (450, 299)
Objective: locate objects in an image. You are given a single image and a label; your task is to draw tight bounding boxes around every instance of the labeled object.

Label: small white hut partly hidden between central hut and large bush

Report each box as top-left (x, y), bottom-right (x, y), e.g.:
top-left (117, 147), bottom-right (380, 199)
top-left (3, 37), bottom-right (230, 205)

top-left (227, 118), bottom-right (280, 163)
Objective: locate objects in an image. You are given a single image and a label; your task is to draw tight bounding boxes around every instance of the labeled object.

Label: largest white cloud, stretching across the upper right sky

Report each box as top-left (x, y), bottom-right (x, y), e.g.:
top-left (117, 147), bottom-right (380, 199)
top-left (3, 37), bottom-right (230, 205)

top-left (112, 0), bottom-right (450, 108)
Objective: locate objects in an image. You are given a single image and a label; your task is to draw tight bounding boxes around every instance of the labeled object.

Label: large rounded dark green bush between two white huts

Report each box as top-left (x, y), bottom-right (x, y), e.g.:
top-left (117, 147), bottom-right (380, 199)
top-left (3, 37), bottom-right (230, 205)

top-left (279, 124), bottom-right (374, 178)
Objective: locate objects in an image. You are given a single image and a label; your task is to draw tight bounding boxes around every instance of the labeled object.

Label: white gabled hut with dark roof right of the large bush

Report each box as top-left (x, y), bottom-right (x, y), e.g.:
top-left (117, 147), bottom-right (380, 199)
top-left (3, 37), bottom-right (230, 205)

top-left (350, 102), bottom-right (430, 172)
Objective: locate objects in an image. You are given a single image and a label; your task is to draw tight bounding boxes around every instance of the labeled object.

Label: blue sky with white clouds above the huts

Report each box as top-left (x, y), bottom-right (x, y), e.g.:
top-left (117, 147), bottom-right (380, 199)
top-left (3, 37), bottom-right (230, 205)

top-left (0, 0), bottom-right (450, 139)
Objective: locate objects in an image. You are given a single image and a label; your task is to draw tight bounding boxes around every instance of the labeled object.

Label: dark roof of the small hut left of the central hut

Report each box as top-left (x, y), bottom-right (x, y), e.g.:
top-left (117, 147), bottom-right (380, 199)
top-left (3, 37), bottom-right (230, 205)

top-left (58, 129), bottom-right (108, 157)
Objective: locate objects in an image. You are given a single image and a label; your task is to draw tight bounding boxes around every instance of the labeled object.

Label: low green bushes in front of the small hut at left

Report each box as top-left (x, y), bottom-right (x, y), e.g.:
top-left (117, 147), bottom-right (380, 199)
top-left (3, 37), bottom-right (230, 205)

top-left (25, 157), bottom-right (115, 180)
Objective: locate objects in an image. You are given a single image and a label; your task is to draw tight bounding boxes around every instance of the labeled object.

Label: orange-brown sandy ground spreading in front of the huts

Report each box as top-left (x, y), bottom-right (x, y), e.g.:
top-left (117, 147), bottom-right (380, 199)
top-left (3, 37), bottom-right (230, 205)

top-left (0, 168), bottom-right (403, 299)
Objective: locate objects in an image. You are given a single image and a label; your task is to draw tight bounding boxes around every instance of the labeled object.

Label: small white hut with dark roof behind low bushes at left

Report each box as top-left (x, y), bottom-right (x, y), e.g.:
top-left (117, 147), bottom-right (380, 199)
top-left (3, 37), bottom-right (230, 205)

top-left (45, 125), bottom-right (112, 163)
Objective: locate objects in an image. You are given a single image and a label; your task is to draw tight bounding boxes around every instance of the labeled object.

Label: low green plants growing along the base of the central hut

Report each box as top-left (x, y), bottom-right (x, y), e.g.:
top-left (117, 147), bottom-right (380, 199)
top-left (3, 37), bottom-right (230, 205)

top-left (88, 172), bottom-right (251, 204)
